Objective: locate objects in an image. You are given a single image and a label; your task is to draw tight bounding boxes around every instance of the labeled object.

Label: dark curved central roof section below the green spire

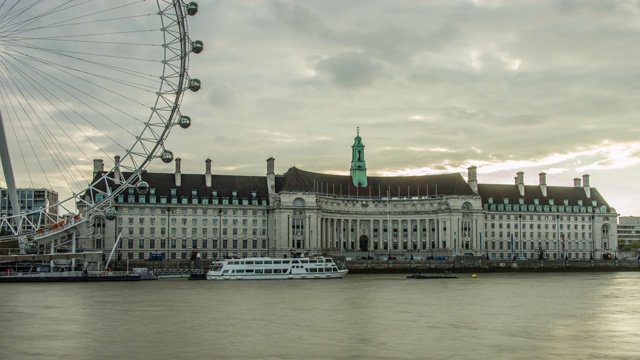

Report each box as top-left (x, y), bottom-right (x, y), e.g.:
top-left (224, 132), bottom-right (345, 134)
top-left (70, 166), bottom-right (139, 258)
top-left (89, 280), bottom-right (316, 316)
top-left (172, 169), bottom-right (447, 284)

top-left (276, 166), bottom-right (475, 197)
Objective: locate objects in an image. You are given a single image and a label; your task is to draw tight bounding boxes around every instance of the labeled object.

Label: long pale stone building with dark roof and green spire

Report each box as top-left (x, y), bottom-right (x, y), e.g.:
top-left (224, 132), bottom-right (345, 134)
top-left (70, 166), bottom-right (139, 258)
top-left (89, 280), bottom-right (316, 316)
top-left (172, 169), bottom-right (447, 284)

top-left (85, 133), bottom-right (618, 260)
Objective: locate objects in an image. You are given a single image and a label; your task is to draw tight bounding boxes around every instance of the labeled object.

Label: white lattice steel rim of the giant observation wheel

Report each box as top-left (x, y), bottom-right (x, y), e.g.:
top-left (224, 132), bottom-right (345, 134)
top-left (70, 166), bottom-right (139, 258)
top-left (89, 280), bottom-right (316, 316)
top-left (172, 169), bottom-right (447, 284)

top-left (0, 0), bottom-right (197, 240)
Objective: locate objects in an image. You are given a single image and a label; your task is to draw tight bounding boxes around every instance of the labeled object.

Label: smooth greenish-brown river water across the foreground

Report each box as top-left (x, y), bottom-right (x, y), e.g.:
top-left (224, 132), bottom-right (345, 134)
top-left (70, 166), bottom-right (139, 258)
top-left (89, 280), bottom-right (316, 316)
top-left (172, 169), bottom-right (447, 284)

top-left (0, 272), bottom-right (640, 360)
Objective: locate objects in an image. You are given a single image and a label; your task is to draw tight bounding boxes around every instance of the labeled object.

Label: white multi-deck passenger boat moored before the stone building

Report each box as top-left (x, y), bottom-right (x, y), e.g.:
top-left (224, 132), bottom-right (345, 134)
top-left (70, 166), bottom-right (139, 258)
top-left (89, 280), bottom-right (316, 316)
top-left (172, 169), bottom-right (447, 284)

top-left (207, 256), bottom-right (349, 280)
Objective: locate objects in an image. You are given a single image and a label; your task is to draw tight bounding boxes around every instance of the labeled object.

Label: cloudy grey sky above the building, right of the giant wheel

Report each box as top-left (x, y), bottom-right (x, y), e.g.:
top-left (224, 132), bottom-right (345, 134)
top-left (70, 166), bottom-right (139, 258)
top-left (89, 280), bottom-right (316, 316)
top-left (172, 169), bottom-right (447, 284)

top-left (0, 0), bottom-right (640, 216)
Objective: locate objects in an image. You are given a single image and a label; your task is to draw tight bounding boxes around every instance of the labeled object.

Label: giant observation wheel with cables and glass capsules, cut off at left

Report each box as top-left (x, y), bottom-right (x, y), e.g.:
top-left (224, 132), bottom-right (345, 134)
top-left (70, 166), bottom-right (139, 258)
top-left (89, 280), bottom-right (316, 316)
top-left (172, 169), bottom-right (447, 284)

top-left (0, 0), bottom-right (203, 250)
